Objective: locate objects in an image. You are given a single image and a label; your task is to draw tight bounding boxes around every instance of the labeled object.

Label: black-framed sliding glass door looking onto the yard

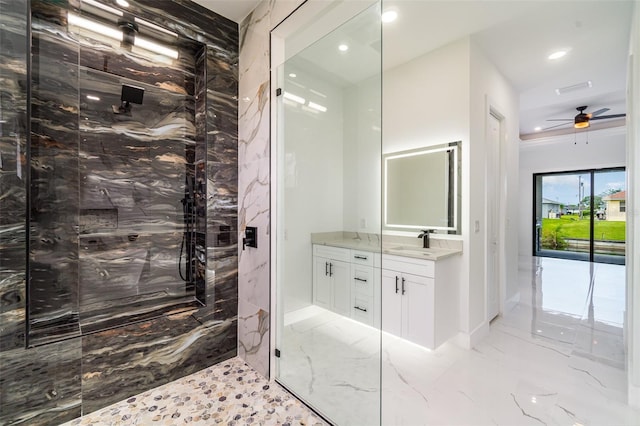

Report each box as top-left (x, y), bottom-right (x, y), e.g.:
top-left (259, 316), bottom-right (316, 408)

top-left (533, 168), bottom-right (626, 264)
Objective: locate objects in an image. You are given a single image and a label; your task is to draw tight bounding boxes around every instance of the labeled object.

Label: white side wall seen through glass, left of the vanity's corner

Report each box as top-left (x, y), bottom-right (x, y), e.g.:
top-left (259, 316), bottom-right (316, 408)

top-left (279, 67), bottom-right (344, 312)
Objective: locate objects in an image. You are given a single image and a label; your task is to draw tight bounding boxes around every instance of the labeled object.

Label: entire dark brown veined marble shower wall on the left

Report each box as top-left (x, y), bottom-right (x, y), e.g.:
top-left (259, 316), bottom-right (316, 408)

top-left (0, 0), bottom-right (238, 425)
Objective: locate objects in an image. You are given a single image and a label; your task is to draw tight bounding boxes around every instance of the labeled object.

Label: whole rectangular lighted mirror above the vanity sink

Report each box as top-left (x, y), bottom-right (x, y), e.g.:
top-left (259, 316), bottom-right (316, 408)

top-left (383, 141), bottom-right (460, 234)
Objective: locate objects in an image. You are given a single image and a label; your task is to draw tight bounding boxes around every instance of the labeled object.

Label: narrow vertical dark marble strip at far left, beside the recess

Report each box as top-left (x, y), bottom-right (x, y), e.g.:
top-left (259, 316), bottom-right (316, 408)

top-left (0, 0), bottom-right (28, 352)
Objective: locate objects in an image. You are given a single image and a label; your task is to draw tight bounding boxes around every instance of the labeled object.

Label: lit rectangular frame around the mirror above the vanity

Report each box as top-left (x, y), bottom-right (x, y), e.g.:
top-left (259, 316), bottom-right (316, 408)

top-left (382, 141), bottom-right (462, 234)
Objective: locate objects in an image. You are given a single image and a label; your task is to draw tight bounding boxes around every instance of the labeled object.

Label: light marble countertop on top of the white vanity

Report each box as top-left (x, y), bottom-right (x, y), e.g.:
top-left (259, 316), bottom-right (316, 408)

top-left (312, 233), bottom-right (462, 260)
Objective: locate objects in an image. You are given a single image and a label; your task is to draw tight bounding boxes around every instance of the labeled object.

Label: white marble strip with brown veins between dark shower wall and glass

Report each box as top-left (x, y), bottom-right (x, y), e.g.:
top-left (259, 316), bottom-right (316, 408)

top-left (238, 0), bottom-right (303, 376)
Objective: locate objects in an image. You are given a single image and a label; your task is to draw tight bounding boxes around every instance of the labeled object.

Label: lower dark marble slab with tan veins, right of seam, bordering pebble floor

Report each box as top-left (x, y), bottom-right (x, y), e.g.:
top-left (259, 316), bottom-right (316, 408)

top-left (82, 312), bottom-right (236, 414)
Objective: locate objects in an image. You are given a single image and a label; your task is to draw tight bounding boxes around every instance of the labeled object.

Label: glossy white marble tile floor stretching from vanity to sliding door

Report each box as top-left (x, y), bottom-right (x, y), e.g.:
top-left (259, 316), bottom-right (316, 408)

top-left (279, 258), bottom-right (640, 426)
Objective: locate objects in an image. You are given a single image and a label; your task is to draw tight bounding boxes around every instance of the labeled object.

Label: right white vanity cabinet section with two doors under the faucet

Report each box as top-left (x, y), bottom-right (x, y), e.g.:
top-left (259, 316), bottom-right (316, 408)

top-left (382, 255), bottom-right (458, 349)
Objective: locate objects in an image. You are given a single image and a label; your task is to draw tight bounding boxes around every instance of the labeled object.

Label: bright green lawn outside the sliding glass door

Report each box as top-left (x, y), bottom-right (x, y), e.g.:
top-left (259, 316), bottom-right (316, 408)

top-left (542, 215), bottom-right (626, 241)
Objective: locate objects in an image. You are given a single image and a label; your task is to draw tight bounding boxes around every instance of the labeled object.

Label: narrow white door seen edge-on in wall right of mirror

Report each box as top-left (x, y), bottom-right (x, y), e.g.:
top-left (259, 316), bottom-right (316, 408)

top-left (486, 114), bottom-right (501, 321)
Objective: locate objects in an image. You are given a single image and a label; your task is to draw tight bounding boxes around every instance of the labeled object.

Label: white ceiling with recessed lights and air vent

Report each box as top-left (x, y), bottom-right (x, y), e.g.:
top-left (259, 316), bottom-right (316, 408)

top-left (197, 0), bottom-right (634, 139)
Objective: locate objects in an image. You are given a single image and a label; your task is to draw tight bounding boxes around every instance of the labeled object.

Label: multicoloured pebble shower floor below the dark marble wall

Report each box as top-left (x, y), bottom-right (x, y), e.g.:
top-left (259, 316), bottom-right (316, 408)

top-left (64, 357), bottom-right (326, 426)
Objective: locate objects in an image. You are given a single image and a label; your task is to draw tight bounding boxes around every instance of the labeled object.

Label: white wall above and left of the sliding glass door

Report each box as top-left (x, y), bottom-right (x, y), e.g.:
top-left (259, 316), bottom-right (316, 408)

top-left (517, 127), bottom-right (626, 256)
